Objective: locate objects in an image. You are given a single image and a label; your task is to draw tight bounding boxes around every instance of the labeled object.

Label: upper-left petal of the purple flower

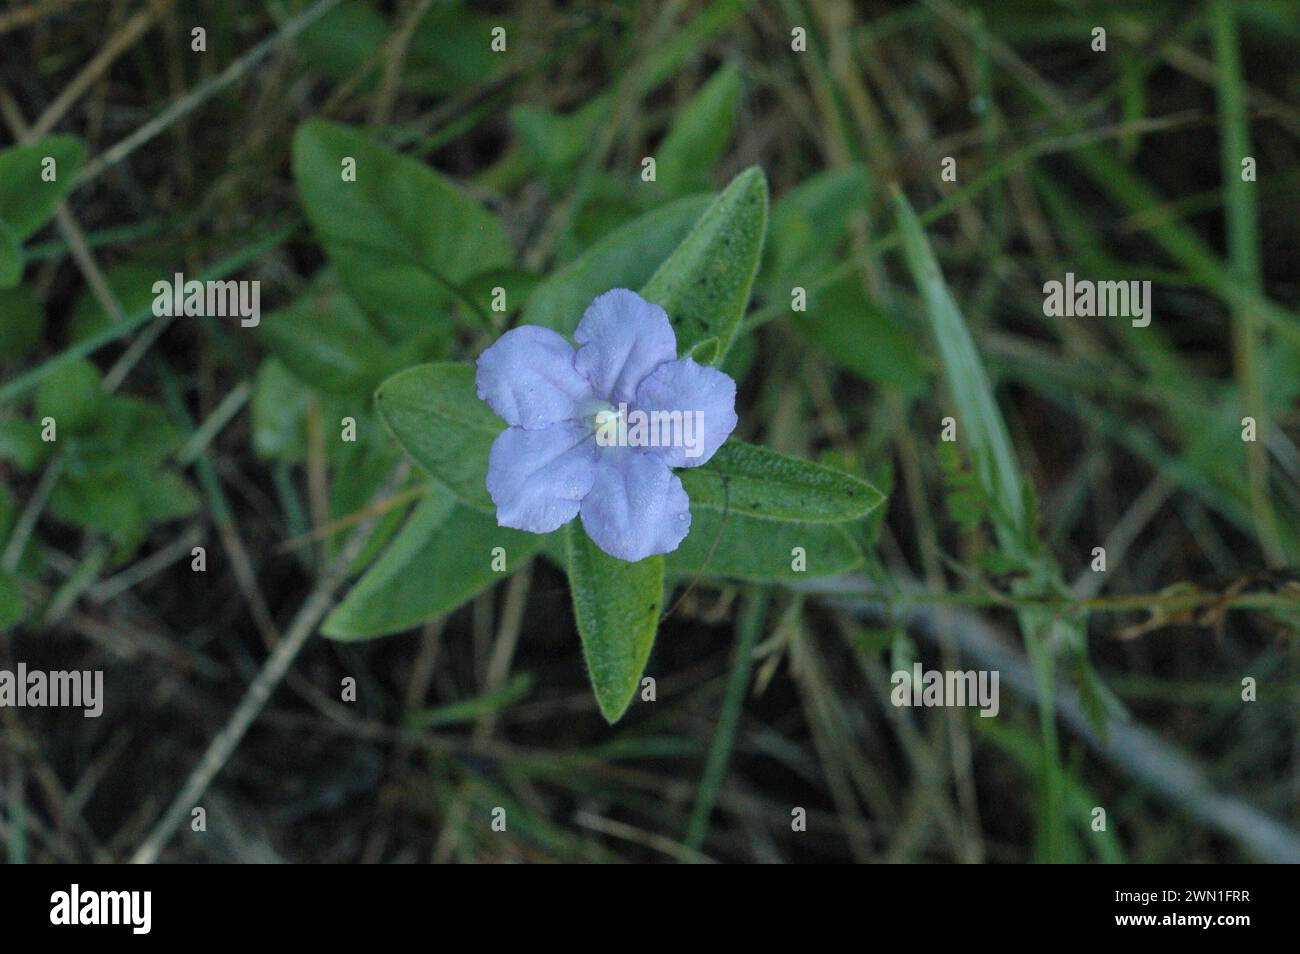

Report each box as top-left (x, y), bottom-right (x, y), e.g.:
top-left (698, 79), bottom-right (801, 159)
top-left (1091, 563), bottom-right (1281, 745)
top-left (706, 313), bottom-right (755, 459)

top-left (475, 325), bottom-right (592, 430)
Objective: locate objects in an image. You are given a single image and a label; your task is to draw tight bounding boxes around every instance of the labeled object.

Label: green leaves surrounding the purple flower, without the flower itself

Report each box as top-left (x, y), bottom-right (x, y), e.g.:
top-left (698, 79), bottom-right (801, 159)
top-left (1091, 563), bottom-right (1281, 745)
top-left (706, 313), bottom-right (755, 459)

top-left (276, 121), bottom-right (883, 721)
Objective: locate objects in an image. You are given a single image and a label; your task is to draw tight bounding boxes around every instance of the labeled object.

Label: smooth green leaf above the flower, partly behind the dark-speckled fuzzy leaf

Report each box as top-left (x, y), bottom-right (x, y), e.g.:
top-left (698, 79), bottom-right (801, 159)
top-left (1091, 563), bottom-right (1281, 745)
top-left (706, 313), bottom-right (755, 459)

top-left (520, 195), bottom-right (710, 335)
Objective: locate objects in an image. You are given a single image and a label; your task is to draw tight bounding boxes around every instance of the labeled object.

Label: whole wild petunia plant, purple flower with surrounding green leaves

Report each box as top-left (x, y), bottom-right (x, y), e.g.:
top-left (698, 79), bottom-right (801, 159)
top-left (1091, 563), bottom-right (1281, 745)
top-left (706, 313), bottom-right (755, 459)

top-left (286, 121), bottom-right (881, 723)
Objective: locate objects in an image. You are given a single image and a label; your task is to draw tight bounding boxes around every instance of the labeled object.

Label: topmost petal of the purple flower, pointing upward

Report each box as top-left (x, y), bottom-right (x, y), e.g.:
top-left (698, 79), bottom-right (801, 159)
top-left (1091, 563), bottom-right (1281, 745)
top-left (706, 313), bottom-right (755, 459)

top-left (573, 289), bottom-right (677, 404)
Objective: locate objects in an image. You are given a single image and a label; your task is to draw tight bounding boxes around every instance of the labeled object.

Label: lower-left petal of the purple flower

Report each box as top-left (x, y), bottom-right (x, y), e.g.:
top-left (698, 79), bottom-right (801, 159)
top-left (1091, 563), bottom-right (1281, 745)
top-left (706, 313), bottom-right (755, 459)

top-left (488, 421), bottom-right (595, 533)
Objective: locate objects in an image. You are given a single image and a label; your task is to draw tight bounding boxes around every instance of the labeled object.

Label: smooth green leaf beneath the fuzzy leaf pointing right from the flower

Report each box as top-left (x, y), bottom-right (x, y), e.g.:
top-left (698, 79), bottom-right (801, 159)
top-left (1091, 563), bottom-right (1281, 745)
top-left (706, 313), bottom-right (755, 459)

top-left (664, 507), bottom-right (862, 582)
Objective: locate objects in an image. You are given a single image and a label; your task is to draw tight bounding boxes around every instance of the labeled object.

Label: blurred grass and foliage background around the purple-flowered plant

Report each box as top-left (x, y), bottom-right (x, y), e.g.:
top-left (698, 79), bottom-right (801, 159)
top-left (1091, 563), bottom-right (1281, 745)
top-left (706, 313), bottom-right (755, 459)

top-left (0, 0), bottom-right (1300, 862)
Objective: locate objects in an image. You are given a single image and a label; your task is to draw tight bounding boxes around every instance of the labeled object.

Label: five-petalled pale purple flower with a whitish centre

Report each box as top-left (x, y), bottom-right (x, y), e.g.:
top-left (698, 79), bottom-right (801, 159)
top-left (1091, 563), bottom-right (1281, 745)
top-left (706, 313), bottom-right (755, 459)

top-left (476, 289), bottom-right (736, 561)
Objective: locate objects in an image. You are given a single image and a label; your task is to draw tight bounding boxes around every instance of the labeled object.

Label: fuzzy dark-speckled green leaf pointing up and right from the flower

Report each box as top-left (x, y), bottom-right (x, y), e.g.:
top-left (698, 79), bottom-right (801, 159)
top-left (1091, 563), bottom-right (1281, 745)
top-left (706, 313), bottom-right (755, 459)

top-left (641, 166), bottom-right (767, 364)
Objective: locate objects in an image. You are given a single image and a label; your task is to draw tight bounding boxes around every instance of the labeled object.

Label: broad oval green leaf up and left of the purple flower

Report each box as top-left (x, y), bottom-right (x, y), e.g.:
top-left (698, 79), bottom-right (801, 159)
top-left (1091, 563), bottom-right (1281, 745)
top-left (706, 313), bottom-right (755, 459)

top-left (294, 120), bottom-right (514, 320)
